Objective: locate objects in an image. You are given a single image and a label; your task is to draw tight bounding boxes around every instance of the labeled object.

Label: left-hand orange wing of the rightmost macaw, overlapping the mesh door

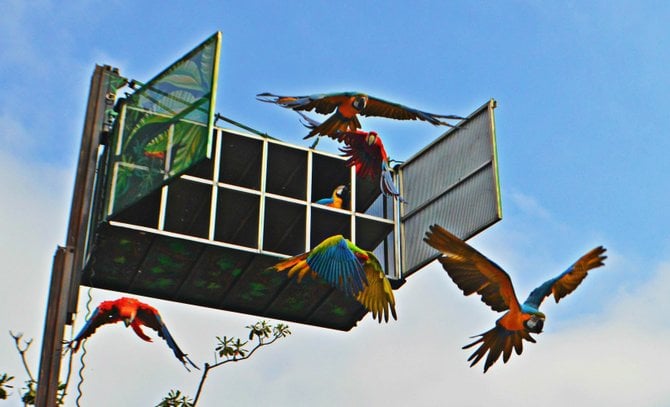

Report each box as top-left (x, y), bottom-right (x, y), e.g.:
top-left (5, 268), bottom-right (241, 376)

top-left (423, 225), bottom-right (520, 313)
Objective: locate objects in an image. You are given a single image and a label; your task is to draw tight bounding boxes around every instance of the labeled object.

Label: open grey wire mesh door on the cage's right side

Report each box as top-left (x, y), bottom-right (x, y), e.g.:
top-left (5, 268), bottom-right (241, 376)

top-left (399, 100), bottom-right (502, 278)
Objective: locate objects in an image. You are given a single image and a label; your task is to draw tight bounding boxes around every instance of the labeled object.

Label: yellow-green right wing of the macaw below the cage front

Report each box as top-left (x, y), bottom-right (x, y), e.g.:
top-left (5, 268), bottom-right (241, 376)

top-left (356, 252), bottom-right (398, 323)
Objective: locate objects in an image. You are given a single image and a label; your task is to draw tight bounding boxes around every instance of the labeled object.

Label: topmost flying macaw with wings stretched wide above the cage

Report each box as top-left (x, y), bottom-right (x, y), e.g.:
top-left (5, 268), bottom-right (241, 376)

top-left (256, 92), bottom-right (463, 139)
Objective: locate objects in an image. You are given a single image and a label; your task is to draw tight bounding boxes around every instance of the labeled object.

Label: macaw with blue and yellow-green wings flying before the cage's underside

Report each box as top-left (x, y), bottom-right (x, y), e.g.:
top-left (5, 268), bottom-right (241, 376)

top-left (272, 235), bottom-right (398, 323)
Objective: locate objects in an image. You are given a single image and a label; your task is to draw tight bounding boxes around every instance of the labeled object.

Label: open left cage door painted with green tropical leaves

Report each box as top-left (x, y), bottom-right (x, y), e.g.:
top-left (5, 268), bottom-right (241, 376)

top-left (106, 33), bottom-right (221, 216)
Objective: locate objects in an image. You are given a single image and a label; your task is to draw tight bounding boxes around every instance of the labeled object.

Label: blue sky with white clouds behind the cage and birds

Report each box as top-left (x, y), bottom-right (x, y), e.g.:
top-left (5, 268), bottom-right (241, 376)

top-left (0, 0), bottom-right (670, 406)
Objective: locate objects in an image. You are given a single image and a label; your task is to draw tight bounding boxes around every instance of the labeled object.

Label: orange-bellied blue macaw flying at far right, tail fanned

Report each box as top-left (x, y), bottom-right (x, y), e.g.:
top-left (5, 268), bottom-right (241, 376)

top-left (424, 225), bottom-right (607, 373)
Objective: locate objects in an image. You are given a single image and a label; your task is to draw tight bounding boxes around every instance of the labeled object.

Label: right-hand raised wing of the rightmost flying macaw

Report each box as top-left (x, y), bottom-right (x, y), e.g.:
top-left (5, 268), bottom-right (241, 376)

top-left (524, 246), bottom-right (607, 309)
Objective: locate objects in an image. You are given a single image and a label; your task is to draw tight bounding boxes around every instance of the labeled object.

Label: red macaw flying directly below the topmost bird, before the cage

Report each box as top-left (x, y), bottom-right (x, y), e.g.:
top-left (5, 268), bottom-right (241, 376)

top-left (298, 112), bottom-right (405, 202)
